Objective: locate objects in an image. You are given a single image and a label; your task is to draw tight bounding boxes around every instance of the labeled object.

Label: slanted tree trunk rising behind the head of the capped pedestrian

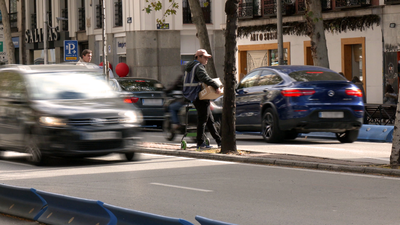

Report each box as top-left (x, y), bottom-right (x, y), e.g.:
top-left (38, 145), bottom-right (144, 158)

top-left (189, 0), bottom-right (218, 78)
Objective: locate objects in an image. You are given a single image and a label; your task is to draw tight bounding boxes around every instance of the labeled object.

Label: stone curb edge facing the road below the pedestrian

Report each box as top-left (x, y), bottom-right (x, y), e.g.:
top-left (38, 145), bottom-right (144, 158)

top-left (136, 147), bottom-right (400, 177)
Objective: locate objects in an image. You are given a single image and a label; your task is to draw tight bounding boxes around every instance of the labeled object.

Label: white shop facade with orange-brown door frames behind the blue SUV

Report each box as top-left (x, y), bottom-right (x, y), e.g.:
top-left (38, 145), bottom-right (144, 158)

top-left (237, 0), bottom-right (400, 104)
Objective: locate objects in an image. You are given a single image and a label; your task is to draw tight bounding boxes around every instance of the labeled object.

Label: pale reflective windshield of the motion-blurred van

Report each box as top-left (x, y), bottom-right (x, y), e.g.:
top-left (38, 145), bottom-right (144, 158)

top-left (26, 72), bottom-right (116, 100)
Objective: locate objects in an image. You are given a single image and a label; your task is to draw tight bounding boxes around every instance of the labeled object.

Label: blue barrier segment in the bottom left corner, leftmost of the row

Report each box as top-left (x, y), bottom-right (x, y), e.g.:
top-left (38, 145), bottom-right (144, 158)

top-left (0, 184), bottom-right (47, 220)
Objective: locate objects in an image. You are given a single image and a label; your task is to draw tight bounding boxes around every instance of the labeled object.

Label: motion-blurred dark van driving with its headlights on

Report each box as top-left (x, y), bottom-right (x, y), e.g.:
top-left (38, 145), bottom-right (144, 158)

top-left (0, 64), bottom-right (142, 165)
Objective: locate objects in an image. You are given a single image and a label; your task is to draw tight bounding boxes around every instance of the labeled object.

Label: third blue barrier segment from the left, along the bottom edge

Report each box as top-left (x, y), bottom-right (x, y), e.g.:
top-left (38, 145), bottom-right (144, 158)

top-left (104, 204), bottom-right (194, 225)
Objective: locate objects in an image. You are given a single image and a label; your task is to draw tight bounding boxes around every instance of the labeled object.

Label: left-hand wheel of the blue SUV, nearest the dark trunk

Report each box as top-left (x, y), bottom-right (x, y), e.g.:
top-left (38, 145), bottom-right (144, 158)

top-left (261, 108), bottom-right (285, 143)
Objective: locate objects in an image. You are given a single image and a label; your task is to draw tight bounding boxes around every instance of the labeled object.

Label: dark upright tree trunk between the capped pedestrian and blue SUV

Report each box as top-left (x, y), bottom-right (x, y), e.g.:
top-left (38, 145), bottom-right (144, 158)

top-left (221, 0), bottom-right (239, 153)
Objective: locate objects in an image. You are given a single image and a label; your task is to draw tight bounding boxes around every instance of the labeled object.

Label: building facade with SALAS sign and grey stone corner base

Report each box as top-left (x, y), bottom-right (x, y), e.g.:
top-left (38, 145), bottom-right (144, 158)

top-left (21, 0), bottom-right (225, 85)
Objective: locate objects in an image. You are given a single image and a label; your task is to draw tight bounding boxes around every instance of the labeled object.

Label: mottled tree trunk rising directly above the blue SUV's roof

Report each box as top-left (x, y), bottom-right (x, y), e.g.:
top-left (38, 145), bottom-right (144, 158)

top-left (305, 0), bottom-right (329, 68)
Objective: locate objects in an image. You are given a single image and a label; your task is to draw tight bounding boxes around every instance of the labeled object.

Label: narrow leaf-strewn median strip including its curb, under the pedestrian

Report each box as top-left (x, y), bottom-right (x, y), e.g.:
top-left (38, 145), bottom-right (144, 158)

top-left (137, 142), bottom-right (400, 177)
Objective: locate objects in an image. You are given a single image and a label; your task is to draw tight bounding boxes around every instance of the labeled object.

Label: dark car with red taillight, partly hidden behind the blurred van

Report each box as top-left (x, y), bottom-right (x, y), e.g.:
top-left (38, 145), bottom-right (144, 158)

top-left (110, 77), bottom-right (166, 128)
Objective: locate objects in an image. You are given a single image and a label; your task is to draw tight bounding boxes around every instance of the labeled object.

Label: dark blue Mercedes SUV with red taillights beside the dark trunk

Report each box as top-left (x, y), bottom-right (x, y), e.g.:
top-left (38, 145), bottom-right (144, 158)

top-left (213, 65), bottom-right (364, 143)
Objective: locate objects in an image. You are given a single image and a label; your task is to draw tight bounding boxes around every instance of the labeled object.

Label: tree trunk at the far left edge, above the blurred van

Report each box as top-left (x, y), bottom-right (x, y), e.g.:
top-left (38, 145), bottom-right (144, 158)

top-left (0, 0), bottom-right (15, 64)
